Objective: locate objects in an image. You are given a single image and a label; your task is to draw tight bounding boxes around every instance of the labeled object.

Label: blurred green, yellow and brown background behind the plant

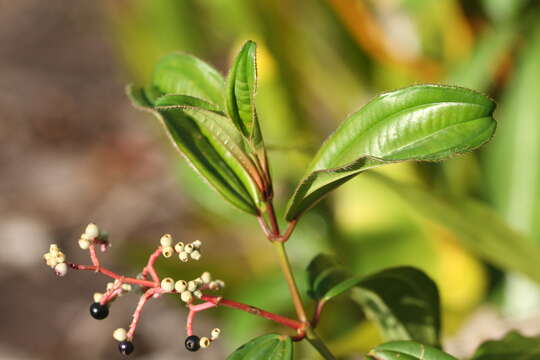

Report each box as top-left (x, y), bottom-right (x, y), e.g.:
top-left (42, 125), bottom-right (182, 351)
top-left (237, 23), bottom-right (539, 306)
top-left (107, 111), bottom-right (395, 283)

top-left (0, 0), bottom-right (540, 359)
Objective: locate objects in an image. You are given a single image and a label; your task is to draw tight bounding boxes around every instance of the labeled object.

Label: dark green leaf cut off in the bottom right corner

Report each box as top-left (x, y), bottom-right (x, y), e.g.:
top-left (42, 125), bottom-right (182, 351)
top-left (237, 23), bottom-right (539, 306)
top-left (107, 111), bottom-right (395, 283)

top-left (471, 331), bottom-right (540, 360)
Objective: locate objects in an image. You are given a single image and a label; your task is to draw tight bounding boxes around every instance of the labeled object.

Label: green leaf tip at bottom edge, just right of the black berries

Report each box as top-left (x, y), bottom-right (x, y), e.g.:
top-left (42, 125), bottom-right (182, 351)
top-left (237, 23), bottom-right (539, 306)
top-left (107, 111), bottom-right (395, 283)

top-left (227, 334), bottom-right (293, 360)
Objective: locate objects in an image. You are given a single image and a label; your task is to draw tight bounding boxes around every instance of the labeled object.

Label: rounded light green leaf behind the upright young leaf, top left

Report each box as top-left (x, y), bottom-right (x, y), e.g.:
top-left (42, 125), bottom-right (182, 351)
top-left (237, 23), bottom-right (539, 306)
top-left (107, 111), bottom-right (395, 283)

top-left (152, 53), bottom-right (225, 109)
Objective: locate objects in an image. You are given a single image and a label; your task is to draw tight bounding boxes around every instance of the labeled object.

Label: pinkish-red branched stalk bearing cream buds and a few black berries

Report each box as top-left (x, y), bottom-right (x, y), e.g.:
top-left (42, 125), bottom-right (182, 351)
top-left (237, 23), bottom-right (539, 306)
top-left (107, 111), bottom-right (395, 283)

top-left (43, 223), bottom-right (231, 355)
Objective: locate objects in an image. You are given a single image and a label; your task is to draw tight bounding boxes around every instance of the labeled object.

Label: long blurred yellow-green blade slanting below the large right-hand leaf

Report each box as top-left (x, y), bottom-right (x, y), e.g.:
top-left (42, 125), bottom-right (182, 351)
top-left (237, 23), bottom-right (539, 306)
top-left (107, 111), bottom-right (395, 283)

top-left (370, 173), bottom-right (540, 283)
